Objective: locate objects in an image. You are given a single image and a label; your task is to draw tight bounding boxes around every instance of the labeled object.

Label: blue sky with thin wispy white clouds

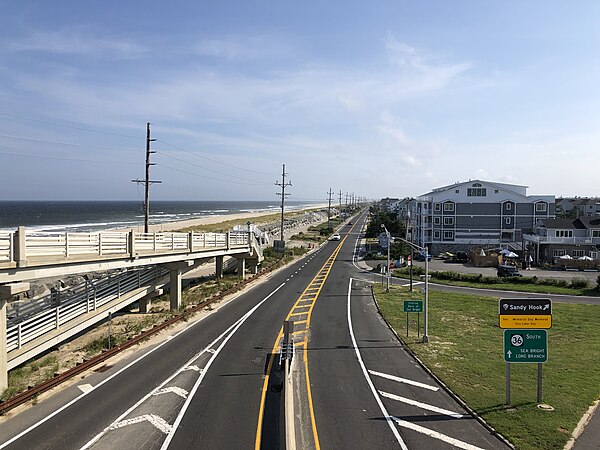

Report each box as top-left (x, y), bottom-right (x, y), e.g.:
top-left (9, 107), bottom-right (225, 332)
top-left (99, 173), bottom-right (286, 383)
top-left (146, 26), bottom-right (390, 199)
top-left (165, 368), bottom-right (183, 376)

top-left (0, 0), bottom-right (600, 200)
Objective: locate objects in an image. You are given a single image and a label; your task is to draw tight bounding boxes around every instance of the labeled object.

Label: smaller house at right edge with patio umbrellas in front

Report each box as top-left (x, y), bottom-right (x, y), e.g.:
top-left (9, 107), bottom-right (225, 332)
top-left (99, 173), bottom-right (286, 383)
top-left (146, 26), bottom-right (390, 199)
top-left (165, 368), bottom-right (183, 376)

top-left (523, 217), bottom-right (600, 264)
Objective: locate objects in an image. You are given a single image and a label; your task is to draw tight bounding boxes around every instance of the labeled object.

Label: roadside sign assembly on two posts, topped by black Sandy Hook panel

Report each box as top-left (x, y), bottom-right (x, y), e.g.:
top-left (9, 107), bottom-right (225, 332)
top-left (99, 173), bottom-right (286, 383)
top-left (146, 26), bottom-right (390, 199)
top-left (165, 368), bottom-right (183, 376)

top-left (498, 298), bottom-right (552, 405)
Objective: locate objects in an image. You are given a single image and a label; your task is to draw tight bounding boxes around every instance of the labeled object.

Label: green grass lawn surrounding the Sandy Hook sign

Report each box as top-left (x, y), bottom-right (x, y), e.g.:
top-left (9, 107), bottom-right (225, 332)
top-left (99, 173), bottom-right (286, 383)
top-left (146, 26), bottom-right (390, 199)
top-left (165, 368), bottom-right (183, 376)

top-left (374, 285), bottom-right (600, 449)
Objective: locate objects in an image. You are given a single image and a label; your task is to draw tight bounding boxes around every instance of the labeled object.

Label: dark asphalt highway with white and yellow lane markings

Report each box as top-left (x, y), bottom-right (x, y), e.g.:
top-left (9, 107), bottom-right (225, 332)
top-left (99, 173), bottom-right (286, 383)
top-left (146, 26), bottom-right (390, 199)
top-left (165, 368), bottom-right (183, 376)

top-left (0, 215), bottom-right (506, 449)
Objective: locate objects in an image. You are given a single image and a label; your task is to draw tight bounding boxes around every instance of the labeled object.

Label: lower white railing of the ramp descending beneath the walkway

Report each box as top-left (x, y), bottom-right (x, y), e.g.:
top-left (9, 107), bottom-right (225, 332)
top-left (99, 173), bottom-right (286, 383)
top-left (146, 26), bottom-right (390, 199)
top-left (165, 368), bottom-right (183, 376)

top-left (6, 267), bottom-right (168, 352)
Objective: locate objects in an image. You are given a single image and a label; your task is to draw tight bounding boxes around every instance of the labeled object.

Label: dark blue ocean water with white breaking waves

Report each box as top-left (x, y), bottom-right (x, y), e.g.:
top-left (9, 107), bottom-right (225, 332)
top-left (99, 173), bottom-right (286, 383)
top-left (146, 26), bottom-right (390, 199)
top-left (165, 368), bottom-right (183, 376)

top-left (0, 201), bottom-right (310, 231)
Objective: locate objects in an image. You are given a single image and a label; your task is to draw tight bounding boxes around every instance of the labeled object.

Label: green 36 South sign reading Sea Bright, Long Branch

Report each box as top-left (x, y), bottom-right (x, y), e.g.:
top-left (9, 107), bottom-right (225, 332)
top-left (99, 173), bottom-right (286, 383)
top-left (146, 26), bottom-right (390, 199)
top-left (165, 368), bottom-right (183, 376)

top-left (504, 330), bottom-right (548, 363)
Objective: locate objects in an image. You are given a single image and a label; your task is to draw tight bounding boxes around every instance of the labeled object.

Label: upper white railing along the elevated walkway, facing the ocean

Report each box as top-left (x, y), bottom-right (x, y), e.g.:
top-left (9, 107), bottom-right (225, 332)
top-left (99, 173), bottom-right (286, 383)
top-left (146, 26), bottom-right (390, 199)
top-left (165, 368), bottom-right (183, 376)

top-left (0, 227), bottom-right (258, 267)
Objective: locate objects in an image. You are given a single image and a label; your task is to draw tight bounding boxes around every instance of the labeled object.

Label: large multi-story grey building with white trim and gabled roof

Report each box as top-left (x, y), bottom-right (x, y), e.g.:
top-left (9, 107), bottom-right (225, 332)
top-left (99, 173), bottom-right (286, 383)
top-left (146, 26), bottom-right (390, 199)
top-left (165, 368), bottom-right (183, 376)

top-left (410, 180), bottom-right (555, 254)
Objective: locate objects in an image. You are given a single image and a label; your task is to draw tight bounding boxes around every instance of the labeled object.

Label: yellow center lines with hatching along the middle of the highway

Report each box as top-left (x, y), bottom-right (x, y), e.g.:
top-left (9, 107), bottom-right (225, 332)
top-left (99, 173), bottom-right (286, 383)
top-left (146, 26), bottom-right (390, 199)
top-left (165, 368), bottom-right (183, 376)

top-left (254, 236), bottom-right (347, 450)
